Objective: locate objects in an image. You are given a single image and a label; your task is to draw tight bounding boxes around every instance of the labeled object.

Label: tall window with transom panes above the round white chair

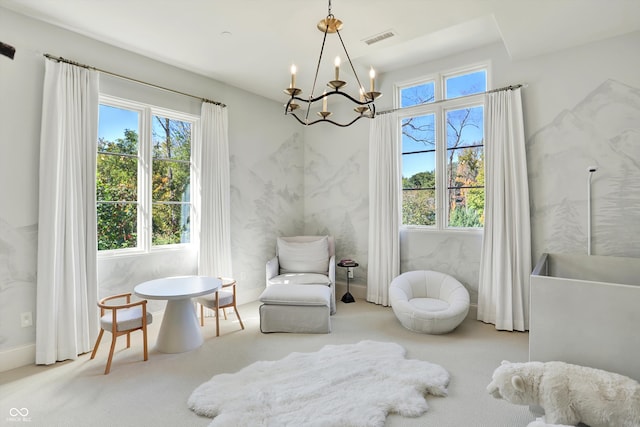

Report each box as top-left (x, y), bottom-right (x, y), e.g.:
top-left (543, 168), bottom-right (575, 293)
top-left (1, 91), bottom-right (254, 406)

top-left (397, 68), bottom-right (487, 229)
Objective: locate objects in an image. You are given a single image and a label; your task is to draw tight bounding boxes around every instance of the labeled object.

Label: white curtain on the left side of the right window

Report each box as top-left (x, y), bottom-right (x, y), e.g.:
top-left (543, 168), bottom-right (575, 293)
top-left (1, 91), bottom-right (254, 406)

top-left (367, 113), bottom-right (401, 306)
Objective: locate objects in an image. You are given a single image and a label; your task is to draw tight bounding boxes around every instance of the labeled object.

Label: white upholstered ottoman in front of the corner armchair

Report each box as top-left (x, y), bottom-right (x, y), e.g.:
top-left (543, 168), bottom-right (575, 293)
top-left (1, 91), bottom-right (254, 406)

top-left (260, 284), bottom-right (331, 334)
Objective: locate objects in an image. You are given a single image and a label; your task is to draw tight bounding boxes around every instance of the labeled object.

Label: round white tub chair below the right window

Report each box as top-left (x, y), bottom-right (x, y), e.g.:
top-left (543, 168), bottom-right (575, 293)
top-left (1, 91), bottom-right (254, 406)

top-left (389, 270), bottom-right (469, 334)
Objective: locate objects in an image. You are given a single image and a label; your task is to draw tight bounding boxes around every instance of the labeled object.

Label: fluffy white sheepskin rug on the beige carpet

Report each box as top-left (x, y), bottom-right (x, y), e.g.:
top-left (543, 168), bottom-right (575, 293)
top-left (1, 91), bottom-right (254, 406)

top-left (188, 341), bottom-right (449, 427)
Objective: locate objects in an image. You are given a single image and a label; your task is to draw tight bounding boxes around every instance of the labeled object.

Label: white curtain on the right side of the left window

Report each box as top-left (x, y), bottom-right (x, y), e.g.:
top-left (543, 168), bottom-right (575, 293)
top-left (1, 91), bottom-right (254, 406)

top-left (194, 102), bottom-right (233, 277)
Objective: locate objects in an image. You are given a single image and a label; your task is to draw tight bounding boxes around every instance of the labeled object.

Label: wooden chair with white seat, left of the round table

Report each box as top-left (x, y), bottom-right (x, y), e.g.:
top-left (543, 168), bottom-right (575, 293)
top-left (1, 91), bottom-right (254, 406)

top-left (91, 293), bottom-right (153, 375)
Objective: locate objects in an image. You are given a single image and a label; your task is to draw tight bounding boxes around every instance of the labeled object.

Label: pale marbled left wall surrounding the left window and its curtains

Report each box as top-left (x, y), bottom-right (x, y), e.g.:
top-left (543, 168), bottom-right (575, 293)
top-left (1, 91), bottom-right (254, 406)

top-left (0, 8), bottom-right (304, 371)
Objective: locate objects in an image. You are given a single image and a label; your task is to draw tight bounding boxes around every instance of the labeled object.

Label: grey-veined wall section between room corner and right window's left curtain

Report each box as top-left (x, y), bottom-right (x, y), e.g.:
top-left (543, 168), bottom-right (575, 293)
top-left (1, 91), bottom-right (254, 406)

top-left (304, 120), bottom-right (369, 286)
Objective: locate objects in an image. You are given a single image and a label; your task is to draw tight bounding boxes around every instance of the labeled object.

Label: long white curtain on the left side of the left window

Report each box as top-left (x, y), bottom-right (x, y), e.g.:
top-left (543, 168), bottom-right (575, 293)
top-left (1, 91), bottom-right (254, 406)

top-left (36, 59), bottom-right (99, 364)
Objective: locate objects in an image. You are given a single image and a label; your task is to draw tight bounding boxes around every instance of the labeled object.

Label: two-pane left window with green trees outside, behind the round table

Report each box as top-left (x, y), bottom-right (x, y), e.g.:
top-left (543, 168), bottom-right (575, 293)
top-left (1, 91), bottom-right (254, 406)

top-left (96, 97), bottom-right (197, 251)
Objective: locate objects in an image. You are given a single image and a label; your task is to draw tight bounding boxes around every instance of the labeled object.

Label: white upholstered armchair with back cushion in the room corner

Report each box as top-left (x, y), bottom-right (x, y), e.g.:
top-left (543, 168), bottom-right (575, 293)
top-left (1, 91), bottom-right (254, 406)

top-left (266, 236), bottom-right (336, 314)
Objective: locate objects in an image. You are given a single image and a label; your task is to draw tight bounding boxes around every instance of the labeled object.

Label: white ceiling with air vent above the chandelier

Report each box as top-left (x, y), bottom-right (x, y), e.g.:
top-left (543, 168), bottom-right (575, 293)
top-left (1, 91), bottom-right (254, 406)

top-left (0, 0), bottom-right (640, 101)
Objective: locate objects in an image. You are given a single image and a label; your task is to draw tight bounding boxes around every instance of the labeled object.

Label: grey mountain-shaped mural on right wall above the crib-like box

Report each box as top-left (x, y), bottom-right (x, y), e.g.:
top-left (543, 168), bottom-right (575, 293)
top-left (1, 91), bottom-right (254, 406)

top-left (527, 79), bottom-right (640, 259)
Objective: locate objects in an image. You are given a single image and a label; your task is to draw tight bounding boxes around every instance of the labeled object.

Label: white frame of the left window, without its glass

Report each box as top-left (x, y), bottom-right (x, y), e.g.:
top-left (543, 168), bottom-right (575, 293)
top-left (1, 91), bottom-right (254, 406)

top-left (95, 93), bottom-right (200, 258)
